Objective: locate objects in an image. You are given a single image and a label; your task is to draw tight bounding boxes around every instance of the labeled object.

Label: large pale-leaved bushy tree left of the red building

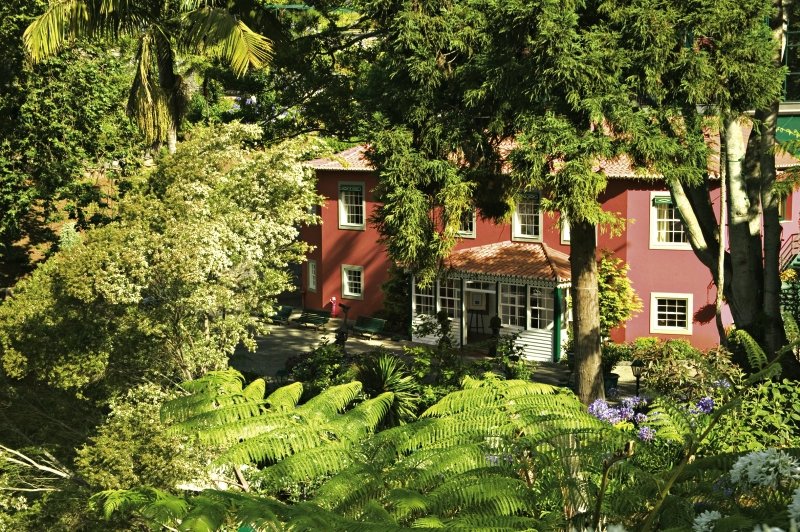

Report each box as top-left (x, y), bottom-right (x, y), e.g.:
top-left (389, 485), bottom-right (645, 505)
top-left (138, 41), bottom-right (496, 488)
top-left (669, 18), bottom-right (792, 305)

top-left (0, 124), bottom-right (318, 393)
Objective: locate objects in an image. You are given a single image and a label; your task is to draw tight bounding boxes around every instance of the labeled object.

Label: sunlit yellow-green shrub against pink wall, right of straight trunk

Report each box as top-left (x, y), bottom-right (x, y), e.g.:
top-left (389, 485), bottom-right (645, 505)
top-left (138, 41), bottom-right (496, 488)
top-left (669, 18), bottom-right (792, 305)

top-left (597, 250), bottom-right (642, 336)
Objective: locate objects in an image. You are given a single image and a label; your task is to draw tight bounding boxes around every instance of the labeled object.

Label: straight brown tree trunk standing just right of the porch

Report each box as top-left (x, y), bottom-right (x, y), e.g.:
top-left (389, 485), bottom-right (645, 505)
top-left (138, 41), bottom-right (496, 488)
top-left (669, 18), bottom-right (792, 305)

top-left (570, 221), bottom-right (605, 405)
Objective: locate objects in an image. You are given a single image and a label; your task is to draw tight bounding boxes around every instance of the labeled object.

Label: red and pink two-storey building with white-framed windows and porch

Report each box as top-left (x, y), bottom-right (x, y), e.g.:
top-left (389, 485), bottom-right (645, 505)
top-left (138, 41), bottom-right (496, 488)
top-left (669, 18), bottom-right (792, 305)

top-left (301, 147), bottom-right (798, 361)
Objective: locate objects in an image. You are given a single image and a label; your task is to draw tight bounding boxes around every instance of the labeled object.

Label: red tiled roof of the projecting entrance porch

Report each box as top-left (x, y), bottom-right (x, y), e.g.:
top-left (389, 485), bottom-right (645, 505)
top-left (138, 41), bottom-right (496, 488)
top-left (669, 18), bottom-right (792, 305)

top-left (446, 241), bottom-right (571, 283)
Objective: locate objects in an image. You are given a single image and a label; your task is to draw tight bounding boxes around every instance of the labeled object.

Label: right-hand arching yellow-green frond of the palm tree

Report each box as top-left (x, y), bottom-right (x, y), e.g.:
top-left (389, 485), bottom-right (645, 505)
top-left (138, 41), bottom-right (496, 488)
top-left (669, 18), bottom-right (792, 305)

top-left (183, 7), bottom-right (272, 76)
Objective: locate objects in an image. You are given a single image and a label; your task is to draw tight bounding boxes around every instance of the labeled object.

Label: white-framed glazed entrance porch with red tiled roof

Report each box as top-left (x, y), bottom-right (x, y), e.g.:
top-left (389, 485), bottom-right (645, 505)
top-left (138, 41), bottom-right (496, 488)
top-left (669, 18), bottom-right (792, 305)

top-left (411, 242), bottom-right (570, 362)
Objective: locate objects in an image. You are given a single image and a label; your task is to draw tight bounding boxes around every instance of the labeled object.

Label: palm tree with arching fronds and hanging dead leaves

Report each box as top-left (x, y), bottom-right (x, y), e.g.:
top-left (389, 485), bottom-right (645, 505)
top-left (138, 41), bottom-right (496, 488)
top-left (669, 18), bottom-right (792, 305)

top-left (23, 0), bottom-right (272, 153)
